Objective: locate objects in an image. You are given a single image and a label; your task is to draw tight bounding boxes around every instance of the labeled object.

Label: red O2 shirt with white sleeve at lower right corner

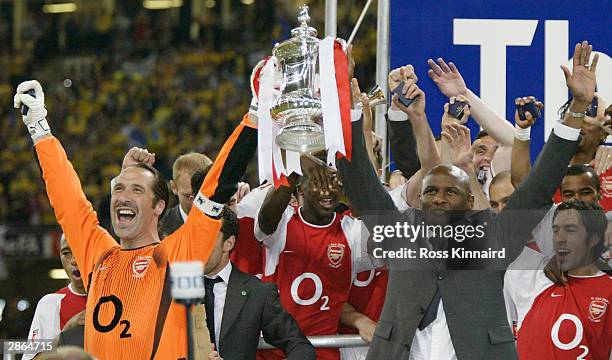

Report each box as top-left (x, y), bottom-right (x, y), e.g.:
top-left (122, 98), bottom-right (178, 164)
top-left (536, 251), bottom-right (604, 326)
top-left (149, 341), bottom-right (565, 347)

top-left (505, 248), bottom-right (612, 360)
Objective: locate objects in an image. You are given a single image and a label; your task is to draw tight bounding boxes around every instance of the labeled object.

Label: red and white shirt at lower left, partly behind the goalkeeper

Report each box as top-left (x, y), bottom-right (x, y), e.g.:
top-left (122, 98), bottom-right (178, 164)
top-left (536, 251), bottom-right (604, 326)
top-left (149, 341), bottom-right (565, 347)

top-left (23, 285), bottom-right (87, 360)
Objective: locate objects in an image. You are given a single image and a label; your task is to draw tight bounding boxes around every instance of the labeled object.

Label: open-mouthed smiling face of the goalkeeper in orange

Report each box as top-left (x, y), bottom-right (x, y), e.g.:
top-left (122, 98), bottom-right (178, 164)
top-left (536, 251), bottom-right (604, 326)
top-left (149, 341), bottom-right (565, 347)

top-left (111, 166), bottom-right (165, 242)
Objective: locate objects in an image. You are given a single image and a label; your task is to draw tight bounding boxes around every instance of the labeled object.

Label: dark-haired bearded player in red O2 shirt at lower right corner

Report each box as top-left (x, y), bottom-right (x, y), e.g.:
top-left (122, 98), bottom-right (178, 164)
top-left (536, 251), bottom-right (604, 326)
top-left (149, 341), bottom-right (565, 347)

top-left (505, 200), bottom-right (612, 359)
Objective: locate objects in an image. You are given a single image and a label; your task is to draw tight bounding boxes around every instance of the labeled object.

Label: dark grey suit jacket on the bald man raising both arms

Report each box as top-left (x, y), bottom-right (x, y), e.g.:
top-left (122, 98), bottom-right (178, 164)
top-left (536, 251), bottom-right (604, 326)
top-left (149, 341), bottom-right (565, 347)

top-left (338, 121), bottom-right (578, 360)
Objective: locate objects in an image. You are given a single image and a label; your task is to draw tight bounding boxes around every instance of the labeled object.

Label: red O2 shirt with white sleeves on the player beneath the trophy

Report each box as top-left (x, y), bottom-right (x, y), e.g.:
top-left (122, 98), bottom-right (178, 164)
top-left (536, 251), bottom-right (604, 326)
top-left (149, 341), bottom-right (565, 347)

top-left (255, 206), bottom-right (373, 359)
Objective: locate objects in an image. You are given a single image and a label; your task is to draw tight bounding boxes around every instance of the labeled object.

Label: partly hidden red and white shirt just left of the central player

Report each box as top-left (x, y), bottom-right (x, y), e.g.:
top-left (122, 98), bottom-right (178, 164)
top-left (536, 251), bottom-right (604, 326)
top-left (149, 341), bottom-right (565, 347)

top-left (230, 185), bottom-right (272, 279)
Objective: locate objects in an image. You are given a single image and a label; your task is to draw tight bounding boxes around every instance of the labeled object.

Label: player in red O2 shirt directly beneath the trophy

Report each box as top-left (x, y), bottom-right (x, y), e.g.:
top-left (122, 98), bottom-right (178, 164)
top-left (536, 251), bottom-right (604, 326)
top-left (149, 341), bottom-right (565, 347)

top-left (255, 156), bottom-right (371, 359)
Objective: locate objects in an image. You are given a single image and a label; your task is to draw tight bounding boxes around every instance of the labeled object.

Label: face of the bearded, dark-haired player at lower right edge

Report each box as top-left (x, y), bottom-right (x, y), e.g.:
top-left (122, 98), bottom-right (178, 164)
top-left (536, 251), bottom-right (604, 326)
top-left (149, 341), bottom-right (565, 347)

top-left (553, 209), bottom-right (597, 271)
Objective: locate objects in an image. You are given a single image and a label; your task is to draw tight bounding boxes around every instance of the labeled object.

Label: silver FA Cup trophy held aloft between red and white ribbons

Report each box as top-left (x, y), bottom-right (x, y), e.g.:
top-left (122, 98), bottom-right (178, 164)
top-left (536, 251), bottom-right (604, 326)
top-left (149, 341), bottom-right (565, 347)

top-left (270, 5), bottom-right (325, 153)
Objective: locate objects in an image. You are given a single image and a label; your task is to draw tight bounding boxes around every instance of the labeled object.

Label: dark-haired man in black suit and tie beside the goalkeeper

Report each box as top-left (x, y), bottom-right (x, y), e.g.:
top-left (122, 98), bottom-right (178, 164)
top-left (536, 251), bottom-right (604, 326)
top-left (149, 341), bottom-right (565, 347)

top-left (191, 171), bottom-right (315, 360)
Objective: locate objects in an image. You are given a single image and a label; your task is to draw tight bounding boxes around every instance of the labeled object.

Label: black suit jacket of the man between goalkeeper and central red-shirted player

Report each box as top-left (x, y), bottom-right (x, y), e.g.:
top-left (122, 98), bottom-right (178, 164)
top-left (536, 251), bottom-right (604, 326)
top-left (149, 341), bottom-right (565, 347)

top-left (219, 265), bottom-right (316, 360)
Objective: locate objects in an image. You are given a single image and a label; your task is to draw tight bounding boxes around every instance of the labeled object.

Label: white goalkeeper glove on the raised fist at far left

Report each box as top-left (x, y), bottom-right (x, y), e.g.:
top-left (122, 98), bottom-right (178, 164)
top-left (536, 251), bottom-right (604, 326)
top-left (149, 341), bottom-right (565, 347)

top-left (13, 80), bottom-right (51, 143)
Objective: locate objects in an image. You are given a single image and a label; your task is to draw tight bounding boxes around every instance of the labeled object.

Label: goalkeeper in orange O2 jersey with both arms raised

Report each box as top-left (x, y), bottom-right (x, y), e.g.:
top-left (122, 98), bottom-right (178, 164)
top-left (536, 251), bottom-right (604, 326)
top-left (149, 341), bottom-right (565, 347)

top-left (14, 81), bottom-right (257, 360)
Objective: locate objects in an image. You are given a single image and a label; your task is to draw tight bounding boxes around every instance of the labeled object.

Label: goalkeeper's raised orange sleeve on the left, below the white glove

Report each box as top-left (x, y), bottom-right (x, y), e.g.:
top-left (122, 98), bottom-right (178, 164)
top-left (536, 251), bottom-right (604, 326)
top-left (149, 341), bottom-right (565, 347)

top-left (35, 137), bottom-right (118, 288)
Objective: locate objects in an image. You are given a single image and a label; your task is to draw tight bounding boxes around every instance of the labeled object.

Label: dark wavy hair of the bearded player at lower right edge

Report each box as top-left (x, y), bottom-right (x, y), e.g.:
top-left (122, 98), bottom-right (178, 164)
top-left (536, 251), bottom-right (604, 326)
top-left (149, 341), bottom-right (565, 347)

top-left (553, 200), bottom-right (608, 261)
